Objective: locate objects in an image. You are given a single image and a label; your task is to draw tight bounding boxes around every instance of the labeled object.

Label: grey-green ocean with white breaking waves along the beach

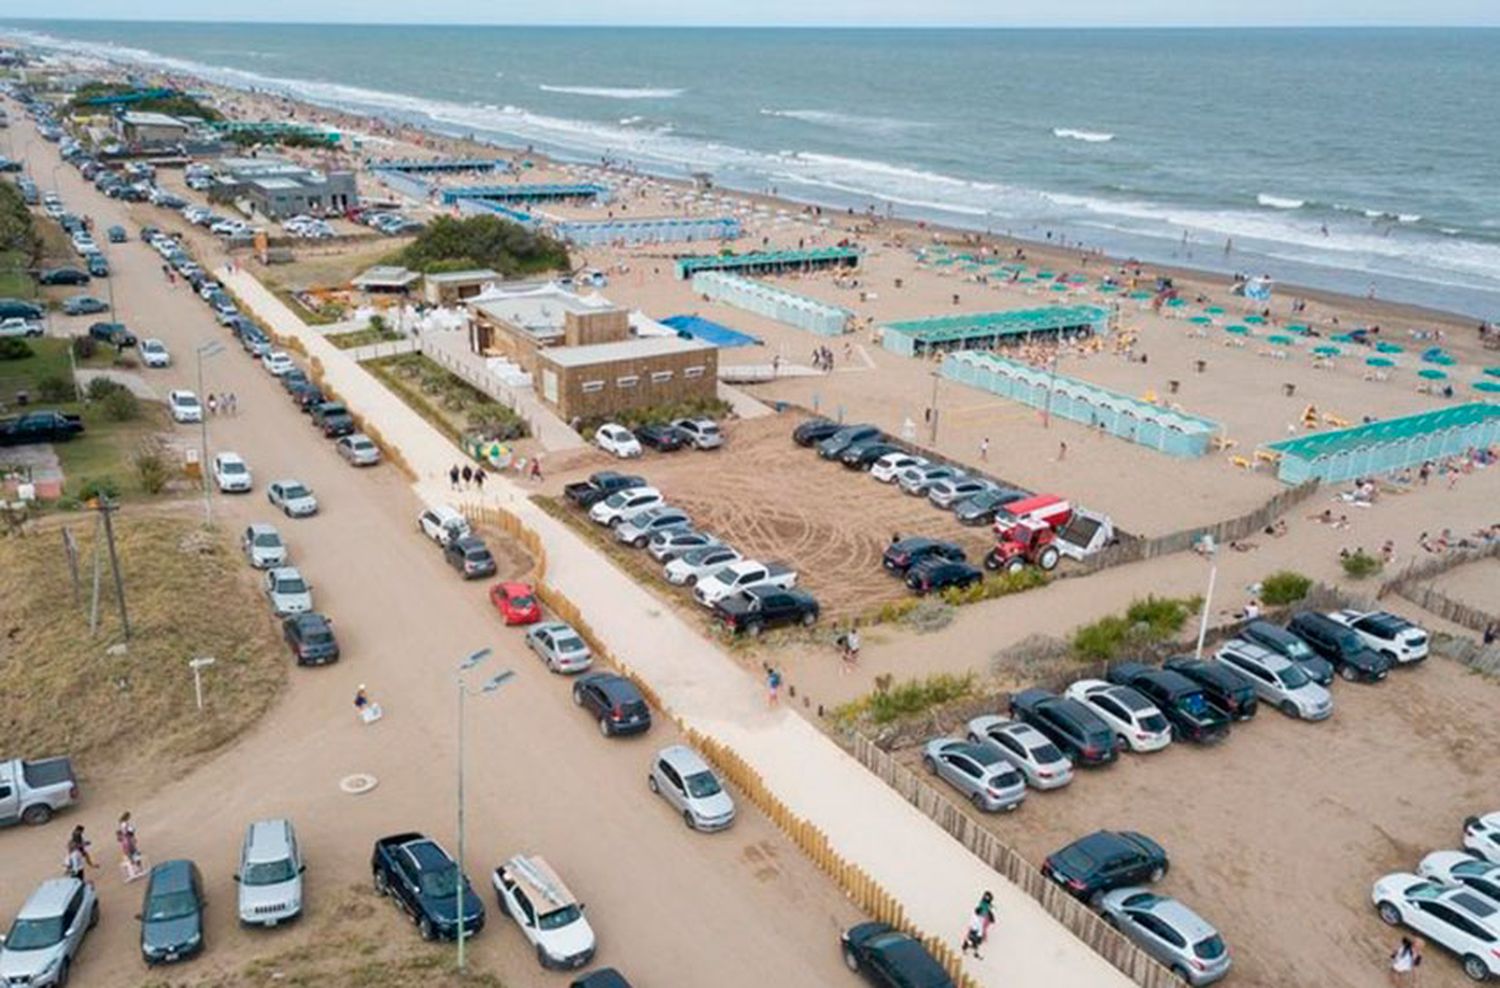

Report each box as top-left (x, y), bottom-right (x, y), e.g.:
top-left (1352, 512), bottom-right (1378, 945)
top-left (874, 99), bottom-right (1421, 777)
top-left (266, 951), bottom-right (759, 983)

top-left (2, 21), bottom-right (1500, 318)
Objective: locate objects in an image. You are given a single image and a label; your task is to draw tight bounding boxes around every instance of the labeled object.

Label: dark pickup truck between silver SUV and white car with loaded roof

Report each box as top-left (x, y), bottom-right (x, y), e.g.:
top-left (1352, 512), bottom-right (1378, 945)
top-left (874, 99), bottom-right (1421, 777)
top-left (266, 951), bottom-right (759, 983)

top-left (371, 834), bottom-right (485, 940)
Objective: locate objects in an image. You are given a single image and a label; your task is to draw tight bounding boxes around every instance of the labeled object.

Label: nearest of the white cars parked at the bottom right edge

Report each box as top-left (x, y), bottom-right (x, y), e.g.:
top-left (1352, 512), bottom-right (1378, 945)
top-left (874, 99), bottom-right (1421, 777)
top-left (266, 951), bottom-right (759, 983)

top-left (1370, 871), bottom-right (1500, 981)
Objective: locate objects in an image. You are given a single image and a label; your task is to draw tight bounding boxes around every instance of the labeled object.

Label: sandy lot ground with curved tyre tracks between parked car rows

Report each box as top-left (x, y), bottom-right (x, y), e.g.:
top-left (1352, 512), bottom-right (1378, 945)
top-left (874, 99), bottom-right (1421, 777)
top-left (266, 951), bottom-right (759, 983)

top-left (549, 414), bottom-right (993, 619)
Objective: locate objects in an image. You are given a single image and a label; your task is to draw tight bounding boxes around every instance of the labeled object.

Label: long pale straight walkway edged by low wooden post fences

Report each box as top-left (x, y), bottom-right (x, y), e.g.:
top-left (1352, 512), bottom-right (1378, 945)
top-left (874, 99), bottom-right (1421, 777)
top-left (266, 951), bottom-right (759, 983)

top-left (225, 273), bottom-right (1131, 988)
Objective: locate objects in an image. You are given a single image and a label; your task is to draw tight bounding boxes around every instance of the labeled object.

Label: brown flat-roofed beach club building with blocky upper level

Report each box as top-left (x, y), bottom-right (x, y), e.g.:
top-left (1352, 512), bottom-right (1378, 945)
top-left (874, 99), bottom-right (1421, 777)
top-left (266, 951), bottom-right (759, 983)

top-left (468, 282), bottom-right (719, 421)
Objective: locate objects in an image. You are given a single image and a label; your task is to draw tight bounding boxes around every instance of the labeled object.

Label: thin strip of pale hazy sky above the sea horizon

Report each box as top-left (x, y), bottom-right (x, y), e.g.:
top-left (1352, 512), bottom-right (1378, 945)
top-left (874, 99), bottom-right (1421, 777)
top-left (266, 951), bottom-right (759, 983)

top-left (0, 0), bottom-right (1500, 27)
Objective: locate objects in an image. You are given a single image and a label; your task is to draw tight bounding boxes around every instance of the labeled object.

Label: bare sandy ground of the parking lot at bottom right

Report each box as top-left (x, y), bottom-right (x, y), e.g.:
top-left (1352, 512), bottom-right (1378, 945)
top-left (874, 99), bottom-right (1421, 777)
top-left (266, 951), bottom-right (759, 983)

top-left (902, 658), bottom-right (1500, 988)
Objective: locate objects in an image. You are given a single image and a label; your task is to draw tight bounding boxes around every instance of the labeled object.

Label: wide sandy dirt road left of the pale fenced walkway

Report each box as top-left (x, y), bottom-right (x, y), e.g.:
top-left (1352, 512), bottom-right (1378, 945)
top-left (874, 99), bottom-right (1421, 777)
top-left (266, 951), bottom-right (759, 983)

top-left (0, 111), bottom-right (858, 988)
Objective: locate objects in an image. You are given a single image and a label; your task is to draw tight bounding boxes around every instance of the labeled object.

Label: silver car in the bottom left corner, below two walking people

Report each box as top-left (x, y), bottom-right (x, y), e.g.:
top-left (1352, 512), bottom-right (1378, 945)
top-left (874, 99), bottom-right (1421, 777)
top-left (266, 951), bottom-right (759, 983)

top-left (0, 879), bottom-right (99, 988)
